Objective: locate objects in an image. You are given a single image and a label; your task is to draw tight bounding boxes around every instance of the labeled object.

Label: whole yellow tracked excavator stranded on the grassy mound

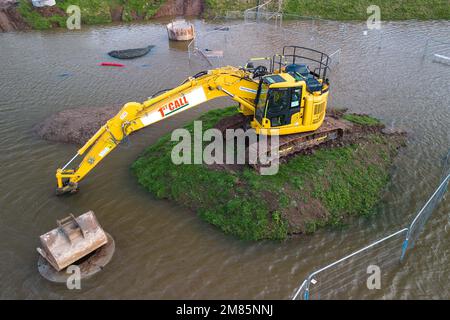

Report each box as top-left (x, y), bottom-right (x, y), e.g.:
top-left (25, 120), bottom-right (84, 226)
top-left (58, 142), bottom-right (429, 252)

top-left (56, 46), bottom-right (343, 195)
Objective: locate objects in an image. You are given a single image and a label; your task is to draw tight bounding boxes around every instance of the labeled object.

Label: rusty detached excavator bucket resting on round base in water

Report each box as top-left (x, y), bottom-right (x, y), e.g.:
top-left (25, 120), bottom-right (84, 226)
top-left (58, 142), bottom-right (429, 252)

top-left (37, 211), bottom-right (108, 271)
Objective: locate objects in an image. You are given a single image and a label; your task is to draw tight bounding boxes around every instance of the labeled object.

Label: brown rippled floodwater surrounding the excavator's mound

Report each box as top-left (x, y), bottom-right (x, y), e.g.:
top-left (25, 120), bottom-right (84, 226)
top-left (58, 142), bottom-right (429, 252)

top-left (0, 20), bottom-right (450, 299)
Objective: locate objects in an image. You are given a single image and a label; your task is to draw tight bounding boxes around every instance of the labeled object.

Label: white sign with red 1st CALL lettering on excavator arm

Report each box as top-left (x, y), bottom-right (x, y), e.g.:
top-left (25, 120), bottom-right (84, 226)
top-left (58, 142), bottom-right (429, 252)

top-left (141, 88), bottom-right (207, 126)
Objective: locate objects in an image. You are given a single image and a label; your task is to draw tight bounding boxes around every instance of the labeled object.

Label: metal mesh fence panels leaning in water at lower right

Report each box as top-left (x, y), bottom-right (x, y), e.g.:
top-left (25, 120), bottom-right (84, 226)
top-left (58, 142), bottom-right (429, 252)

top-left (292, 151), bottom-right (450, 300)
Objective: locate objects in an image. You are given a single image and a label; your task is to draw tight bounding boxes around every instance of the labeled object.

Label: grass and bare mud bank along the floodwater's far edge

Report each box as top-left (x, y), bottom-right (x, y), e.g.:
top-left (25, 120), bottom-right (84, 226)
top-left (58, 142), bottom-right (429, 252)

top-left (7, 0), bottom-right (450, 31)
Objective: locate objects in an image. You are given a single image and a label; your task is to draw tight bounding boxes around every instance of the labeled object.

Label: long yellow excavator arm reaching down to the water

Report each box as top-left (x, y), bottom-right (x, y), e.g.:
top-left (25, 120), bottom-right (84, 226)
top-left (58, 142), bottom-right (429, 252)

top-left (56, 66), bottom-right (258, 194)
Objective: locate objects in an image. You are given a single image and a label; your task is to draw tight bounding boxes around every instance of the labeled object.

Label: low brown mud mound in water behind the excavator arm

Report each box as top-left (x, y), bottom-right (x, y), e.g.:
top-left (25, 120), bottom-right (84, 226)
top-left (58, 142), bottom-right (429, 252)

top-left (34, 106), bottom-right (121, 145)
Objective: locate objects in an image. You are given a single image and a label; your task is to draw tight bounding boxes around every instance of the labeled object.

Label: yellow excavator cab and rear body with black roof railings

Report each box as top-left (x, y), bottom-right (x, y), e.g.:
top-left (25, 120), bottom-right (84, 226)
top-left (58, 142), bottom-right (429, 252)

top-left (251, 46), bottom-right (329, 135)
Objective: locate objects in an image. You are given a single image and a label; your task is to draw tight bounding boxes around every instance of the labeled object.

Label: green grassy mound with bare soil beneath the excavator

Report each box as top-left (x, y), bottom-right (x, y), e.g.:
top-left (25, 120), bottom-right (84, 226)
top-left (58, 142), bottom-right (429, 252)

top-left (132, 107), bottom-right (404, 240)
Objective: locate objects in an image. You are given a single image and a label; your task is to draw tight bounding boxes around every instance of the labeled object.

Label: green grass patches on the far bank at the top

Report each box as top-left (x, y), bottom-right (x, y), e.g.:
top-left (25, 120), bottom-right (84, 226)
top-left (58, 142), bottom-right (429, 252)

top-left (15, 0), bottom-right (450, 29)
